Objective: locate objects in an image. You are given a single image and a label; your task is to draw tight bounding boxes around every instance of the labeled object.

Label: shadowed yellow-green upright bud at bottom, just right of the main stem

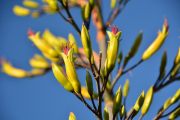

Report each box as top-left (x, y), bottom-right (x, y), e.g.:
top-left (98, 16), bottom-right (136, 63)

top-left (113, 87), bottom-right (122, 115)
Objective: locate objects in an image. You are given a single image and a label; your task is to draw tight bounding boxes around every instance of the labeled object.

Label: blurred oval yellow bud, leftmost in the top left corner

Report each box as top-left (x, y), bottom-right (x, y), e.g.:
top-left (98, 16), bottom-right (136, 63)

top-left (13, 5), bottom-right (30, 16)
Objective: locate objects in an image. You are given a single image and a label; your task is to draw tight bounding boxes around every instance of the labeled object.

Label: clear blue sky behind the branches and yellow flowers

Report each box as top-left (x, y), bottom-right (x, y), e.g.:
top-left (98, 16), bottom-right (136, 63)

top-left (0, 0), bottom-right (180, 120)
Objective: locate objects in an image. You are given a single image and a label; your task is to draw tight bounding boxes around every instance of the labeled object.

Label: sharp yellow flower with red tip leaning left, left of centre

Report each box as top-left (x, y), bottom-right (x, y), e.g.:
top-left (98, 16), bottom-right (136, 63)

top-left (61, 46), bottom-right (81, 93)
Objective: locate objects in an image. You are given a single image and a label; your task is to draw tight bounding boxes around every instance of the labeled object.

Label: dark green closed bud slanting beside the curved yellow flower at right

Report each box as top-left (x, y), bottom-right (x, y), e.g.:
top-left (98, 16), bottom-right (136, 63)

top-left (123, 32), bottom-right (143, 67)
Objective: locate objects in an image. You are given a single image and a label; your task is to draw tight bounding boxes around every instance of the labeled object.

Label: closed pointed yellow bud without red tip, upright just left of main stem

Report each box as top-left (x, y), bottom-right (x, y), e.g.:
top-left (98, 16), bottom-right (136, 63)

top-left (81, 24), bottom-right (94, 63)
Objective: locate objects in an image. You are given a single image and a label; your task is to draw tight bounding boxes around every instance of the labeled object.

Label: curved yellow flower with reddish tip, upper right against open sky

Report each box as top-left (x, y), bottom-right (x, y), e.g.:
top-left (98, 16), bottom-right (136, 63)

top-left (142, 19), bottom-right (169, 60)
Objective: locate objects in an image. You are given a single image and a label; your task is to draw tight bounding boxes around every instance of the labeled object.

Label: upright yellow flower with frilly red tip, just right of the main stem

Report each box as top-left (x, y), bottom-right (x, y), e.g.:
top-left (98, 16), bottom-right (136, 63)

top-left (105, 27), bottom-right (121, 74)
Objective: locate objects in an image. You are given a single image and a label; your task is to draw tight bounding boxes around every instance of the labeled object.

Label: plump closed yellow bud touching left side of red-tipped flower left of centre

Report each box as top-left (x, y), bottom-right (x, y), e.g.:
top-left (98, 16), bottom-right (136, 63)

top-left (52, 63), bottom-right (73, 92)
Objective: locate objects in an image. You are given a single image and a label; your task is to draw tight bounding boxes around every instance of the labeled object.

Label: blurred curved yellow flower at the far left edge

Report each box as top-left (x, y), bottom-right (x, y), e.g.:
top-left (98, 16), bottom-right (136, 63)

top-left (1, 60), bottom-right (28, 78)
